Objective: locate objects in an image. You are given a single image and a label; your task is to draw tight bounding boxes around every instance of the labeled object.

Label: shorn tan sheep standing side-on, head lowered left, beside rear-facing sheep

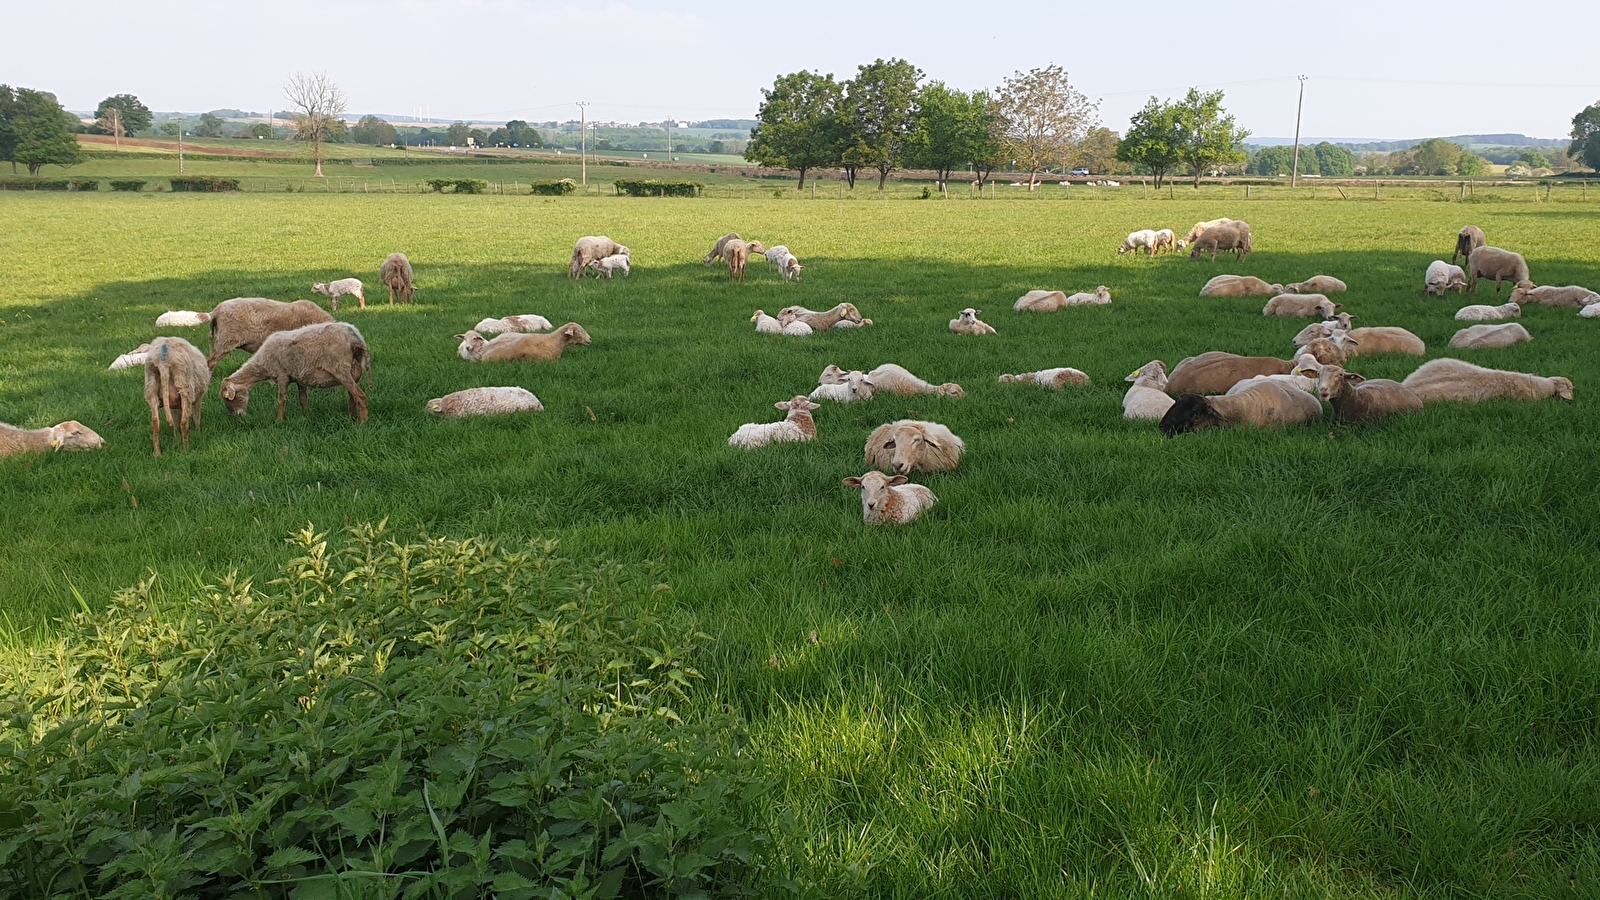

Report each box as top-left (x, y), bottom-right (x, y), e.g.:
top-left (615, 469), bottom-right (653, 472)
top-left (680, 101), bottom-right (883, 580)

top-left (222, 322), bottom-right (373, 421)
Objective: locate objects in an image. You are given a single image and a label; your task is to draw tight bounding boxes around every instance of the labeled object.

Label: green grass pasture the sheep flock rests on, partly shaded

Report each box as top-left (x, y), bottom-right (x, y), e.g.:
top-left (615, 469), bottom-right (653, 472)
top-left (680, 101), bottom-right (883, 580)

top-left (0, 185), bottom-right (1600, 897)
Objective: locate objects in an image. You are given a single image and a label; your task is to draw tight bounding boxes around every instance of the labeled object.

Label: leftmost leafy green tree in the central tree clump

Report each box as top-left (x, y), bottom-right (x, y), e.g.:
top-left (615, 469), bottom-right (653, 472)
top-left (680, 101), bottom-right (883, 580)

top-left (748, 72), bottom-right (845, 191)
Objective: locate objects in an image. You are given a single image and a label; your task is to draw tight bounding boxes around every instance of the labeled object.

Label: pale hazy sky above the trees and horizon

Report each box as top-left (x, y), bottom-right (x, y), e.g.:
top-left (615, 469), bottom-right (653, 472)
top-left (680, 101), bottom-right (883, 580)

top-left (0, 0), bottom-right (1600, 139)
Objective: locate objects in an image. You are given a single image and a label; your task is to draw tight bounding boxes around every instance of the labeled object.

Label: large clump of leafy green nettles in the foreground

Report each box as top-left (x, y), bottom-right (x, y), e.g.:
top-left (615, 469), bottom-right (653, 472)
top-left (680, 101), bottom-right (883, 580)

top-left (0, 522), bottom-right (778, 898)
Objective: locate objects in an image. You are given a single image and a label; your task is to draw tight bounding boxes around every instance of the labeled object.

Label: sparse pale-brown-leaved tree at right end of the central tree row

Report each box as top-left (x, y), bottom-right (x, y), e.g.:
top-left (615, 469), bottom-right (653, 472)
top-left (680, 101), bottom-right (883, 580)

top-left (998, 66), bottom-right (1099, 191)
